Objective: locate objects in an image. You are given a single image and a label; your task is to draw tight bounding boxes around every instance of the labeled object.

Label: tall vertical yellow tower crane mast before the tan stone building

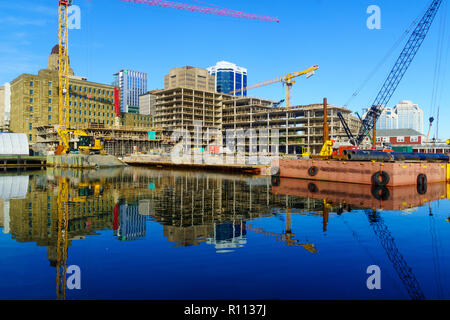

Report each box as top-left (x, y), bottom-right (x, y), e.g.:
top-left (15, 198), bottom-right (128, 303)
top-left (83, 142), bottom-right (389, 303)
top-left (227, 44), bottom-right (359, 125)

top-left (56, 0), bottom-right (72, 154)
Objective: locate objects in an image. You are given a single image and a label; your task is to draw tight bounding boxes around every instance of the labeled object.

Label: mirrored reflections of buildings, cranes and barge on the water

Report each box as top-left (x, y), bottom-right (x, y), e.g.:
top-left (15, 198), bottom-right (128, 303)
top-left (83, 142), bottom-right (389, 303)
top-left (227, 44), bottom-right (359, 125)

top-left (0, 167), bottom-right (450, 299)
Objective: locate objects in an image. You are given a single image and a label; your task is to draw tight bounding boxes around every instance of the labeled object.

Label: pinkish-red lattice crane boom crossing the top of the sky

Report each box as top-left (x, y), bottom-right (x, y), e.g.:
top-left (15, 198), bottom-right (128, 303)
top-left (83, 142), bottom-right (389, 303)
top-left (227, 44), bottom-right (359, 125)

top-left (121, 0), bottom-right (280, 23)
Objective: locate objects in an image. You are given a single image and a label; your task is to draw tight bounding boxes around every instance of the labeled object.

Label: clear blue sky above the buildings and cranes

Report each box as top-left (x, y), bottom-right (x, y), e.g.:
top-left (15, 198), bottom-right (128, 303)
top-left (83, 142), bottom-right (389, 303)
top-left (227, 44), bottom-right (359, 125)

top-left (0, 0), bottom-right (450, 138)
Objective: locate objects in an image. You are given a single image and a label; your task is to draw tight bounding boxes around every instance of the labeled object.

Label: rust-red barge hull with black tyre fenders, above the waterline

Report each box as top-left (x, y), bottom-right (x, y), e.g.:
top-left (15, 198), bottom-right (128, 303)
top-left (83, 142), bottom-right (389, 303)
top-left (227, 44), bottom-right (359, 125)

top-left (272, 159), bottom-right (448, 187)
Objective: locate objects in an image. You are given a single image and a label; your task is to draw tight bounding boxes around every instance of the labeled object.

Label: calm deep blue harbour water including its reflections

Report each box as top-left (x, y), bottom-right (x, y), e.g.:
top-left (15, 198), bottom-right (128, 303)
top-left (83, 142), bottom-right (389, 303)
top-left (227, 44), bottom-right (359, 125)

top-left (0, 168), bottom-right (450, 300)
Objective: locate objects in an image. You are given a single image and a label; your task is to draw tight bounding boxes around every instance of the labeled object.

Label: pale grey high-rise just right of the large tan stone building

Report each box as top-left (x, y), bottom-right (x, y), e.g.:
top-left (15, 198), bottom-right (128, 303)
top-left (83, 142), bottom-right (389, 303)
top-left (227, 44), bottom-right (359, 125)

top-left (113, 69), bottom-right (147, 113)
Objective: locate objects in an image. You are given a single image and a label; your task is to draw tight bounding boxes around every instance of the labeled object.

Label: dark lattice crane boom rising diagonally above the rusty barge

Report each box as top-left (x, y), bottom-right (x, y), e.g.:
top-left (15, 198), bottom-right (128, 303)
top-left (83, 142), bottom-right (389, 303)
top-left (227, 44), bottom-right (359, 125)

top-left (356, 0), bottom-right (442, 145)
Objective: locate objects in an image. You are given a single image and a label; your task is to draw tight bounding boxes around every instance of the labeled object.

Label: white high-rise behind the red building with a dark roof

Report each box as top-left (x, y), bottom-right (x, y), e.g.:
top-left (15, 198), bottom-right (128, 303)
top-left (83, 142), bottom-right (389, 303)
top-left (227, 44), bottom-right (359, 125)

top-left (377, 101), bottom-right (423, 134)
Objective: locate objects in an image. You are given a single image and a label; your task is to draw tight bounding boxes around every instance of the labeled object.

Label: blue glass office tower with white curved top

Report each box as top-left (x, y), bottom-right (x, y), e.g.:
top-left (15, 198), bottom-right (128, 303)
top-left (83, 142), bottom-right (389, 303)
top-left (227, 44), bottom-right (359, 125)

top-left (208, 61), bottom-right (247, 96)
